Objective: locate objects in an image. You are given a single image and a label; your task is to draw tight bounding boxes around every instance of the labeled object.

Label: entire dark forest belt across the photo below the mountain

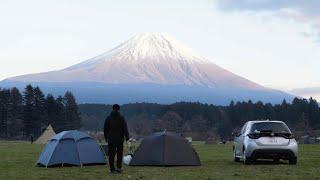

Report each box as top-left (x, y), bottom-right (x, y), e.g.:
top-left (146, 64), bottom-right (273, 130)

top-left (0, 85), bottom-right (320, 140)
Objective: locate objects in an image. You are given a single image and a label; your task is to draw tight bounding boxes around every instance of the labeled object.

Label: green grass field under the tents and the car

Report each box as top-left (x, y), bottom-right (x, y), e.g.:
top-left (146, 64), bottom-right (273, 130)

top-left (0, 141), bottom-right (320, 180)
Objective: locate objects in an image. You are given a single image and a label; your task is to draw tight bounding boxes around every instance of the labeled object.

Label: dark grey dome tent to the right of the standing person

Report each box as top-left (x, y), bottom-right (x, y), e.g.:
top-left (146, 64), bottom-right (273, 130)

top-left (130, 132), bottom-right (201, 166)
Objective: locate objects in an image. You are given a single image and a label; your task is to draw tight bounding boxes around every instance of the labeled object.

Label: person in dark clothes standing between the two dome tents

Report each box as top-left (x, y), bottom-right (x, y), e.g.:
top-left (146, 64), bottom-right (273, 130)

top-left (104, 104), bottom-right (129, 173)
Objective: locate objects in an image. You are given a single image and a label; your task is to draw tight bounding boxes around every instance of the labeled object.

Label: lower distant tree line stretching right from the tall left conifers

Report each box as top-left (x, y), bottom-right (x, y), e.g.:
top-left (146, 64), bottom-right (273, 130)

top-left (79, 98), bottom-right (320, 139)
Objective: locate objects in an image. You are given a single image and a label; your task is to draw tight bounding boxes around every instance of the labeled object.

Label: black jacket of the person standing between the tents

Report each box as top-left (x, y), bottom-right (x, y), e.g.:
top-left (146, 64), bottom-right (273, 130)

top-left (104, 111), bottom-right (129, 144)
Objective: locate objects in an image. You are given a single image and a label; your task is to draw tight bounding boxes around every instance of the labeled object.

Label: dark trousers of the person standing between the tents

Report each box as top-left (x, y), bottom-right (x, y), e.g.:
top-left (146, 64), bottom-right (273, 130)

top-left (108, 143), bottom-right (123, 171)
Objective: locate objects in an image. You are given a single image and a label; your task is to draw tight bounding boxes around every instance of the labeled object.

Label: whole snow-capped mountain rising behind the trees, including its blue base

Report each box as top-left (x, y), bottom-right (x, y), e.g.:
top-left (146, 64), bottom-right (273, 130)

top-left (0, 33), bottom-right (292, 104)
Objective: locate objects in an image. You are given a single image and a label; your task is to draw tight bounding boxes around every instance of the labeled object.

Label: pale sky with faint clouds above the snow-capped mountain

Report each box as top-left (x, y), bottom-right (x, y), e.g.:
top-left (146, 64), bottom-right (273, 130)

top-left (0, 0), bottom-right (320, 89)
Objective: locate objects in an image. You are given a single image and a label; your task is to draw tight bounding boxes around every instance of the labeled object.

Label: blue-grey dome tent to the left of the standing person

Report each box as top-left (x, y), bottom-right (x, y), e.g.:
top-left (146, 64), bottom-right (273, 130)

top-left (37, 130), bottom-right (106, 167)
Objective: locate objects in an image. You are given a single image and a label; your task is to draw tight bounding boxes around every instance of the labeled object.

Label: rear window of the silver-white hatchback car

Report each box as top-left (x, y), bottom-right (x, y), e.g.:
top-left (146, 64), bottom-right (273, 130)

top-left (251, 122), bottom-right (291, 133)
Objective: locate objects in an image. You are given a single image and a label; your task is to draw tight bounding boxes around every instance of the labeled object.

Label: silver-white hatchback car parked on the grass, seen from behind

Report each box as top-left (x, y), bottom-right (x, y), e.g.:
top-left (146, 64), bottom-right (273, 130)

top-left (233, 120), bottom-right (298, 164)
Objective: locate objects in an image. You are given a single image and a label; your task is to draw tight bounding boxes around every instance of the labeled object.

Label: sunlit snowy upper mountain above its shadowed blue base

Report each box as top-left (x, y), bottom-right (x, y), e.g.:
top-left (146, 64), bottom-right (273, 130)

top-left (7, 33), bottom-right (265, 90)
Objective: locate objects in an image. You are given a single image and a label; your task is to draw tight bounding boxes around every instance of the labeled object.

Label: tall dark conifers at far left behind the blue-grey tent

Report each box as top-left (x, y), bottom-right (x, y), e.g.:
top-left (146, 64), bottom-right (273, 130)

top-left (0, 85), bottom-right (81, 139)
